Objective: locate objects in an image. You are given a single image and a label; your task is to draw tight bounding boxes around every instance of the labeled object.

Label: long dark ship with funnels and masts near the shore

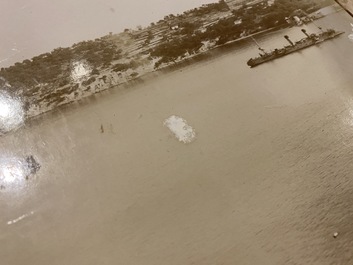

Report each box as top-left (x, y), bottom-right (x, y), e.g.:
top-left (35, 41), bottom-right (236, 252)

top-left (247, 29), bottom-right (344, 67)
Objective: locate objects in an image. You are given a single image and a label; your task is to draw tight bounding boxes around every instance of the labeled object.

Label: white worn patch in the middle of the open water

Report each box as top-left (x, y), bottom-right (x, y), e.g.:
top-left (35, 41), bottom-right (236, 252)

top-left (164, 115), bottom-right (196, 143)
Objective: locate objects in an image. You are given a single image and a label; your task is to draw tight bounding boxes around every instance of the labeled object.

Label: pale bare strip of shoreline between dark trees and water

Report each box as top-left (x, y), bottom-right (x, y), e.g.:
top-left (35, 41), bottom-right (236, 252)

top-left (8, 4), bottom-right (342, 126)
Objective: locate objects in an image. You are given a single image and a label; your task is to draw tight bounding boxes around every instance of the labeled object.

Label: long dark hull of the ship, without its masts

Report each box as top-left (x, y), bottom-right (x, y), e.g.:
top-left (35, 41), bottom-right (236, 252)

top-left (247, 31), bottom-right (344, 68)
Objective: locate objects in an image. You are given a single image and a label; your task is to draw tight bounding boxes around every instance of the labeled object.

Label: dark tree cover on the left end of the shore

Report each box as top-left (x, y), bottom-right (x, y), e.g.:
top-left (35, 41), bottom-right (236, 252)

top-left (0, 39), bottom-right (121, 88)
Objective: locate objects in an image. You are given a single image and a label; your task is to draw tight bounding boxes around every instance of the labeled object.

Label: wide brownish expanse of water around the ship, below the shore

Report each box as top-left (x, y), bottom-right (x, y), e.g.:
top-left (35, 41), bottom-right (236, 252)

top-left (0, 9), bottom-right (353, 265)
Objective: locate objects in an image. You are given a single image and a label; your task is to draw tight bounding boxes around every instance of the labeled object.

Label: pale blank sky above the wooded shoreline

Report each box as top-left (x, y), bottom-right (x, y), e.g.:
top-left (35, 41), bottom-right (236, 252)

top-left (0, 0), bottom-right (217, 67)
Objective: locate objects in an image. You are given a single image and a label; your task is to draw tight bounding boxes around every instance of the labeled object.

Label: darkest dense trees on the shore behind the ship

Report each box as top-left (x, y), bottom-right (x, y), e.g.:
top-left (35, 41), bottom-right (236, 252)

top-left (151, 0), bottom-right (332, 68)
